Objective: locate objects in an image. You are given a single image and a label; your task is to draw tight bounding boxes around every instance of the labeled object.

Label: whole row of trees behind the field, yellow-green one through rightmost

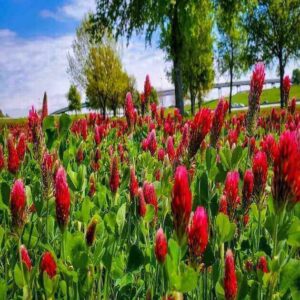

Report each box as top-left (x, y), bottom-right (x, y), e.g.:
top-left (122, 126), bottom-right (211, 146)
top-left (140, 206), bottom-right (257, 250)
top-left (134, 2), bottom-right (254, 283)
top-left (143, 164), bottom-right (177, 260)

top-left (68, 0), bottom-right (300, 113)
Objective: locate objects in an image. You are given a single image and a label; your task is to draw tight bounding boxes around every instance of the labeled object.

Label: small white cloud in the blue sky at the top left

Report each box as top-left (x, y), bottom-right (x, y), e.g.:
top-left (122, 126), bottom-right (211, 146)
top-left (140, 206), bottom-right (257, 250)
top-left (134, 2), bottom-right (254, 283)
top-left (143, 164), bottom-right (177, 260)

top-left (40, 0), bottom-right (96, 21)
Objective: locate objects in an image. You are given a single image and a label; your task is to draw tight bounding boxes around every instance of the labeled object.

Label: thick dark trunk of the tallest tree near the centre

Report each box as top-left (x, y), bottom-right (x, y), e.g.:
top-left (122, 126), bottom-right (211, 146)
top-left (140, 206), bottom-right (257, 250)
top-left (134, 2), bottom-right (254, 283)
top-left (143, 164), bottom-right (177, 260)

top-left (171, 1), bottom-right (184, 115)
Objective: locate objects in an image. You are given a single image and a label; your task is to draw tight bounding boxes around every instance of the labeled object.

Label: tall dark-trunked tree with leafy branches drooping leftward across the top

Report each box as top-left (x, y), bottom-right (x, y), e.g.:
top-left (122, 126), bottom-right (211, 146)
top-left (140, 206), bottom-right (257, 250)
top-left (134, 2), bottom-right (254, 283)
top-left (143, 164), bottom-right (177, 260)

top-left (92, 0), bottom-right (205, 114)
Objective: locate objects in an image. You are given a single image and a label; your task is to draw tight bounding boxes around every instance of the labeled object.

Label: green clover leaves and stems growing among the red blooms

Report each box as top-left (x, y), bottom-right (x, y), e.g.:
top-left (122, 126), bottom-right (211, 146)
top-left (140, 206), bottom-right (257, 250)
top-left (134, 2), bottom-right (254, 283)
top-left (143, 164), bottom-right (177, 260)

top-left (0, 106), bottom-right (300, 299)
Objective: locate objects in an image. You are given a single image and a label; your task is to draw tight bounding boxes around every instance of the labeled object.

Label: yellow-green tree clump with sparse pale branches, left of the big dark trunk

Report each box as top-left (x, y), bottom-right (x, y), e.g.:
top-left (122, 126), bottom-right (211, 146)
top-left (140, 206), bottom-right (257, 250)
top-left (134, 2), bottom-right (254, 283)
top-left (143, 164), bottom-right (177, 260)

top-left (67, 15), bottom-right (135, 114)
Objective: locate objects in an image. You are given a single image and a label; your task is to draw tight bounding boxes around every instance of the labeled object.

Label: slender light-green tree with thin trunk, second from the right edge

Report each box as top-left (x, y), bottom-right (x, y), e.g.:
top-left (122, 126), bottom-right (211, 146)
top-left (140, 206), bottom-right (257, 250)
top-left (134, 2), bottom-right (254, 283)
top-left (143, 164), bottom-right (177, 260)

top-left (215, 0), bottom-right (247, 113)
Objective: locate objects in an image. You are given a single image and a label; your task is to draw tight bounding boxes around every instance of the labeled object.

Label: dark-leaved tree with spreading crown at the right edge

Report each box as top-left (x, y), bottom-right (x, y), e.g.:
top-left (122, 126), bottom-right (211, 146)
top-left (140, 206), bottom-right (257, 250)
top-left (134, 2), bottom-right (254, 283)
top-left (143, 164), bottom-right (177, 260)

top-left (245, 0), bottom-right (300, 108)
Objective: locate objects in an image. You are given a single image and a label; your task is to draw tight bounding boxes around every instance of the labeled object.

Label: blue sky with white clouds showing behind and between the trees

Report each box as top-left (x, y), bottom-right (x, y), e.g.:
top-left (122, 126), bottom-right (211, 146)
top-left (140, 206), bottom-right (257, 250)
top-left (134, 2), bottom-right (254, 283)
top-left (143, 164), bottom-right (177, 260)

top-left (0, 0), bottom-right (296, 117)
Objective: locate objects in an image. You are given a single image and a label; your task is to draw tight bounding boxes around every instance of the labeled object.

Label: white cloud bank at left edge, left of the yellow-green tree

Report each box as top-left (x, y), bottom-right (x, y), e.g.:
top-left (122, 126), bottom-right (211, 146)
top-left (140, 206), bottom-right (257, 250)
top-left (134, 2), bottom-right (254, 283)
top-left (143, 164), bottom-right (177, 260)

top-left (0, 31), bottom-right (73, 116)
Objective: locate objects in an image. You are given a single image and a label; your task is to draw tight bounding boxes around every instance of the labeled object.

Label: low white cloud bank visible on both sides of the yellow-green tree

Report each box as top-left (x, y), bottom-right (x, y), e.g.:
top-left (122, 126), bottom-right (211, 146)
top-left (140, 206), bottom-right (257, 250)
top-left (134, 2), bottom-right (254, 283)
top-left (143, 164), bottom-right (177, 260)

top-left (0, 29), bottom-right (170, 116)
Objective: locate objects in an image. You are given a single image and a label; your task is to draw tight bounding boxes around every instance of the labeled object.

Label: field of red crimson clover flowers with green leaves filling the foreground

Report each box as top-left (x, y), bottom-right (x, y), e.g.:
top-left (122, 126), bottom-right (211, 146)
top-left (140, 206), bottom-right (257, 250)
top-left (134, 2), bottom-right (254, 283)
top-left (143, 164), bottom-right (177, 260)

top-left (0, 64), bottom-right (300, 300)
